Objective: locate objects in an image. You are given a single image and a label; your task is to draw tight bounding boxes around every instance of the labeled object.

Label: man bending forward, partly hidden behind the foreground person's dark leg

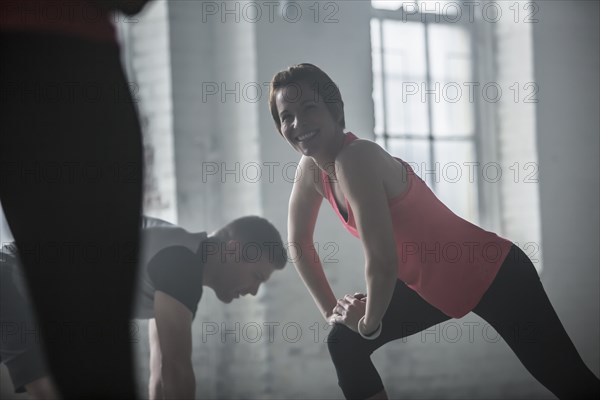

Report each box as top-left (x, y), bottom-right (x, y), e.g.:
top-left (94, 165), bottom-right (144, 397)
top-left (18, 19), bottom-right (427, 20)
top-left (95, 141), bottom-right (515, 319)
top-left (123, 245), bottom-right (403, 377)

top-left (0, 216), bottom-right (287, 399)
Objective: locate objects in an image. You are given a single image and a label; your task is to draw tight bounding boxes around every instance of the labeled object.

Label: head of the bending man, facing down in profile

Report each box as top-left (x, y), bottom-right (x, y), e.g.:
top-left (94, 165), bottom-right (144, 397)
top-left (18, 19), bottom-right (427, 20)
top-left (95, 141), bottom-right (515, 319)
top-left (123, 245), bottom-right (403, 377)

top-left (202, 216), bottom-right (287, 303)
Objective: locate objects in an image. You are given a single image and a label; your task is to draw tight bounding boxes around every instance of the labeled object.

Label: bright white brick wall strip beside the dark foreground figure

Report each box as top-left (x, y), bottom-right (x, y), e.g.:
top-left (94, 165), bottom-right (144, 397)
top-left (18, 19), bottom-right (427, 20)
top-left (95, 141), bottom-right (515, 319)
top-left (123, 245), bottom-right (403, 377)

top-left (117, 0), bottom-right (177, 222)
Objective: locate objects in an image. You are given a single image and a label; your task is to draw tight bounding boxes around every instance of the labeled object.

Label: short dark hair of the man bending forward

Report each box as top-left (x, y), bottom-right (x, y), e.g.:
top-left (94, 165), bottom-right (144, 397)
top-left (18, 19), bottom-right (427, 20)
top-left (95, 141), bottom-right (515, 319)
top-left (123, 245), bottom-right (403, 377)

top-left (216, 215), bottom-right (287, 269)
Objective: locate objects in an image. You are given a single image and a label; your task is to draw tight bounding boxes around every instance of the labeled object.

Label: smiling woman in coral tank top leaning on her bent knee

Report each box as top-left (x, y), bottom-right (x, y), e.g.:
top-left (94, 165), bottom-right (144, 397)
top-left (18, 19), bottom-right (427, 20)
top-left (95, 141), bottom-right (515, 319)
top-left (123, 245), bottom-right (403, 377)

top-left (269, 64), bottom-right (600, 399)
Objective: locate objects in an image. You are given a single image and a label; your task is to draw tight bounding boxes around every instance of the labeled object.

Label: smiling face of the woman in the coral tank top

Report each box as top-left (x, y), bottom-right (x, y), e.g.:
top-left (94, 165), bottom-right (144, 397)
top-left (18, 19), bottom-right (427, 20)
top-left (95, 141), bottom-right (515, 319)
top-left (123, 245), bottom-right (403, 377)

top-left (275, 82), bottom-right (342, 157)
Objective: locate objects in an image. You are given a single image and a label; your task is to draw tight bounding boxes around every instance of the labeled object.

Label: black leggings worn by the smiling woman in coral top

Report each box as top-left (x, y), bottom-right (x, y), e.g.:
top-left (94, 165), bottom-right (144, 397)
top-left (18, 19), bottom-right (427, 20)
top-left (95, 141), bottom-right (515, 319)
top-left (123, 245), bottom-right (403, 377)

top-left (328, 245), bottom-right (600, 399)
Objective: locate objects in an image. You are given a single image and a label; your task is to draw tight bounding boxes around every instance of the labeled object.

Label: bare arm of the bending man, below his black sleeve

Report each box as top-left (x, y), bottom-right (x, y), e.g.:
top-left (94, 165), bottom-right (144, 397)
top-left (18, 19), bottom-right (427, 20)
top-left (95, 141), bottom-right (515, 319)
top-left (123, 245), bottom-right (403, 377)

top-left (154, 290), bottom-right (196, 399)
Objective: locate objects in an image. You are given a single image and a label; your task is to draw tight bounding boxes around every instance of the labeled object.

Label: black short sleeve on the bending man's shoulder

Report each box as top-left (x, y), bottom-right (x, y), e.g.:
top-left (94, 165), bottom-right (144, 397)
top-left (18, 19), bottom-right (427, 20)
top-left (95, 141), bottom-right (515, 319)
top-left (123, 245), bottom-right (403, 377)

top-left (147, 246), bottom-right (204, 317)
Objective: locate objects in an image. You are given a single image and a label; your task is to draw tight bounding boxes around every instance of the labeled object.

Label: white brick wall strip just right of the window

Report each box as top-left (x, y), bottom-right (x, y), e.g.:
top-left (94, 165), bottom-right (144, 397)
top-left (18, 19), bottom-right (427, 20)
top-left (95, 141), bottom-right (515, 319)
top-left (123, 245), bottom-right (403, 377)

top-left (495, 1), bottom-right (542, 271)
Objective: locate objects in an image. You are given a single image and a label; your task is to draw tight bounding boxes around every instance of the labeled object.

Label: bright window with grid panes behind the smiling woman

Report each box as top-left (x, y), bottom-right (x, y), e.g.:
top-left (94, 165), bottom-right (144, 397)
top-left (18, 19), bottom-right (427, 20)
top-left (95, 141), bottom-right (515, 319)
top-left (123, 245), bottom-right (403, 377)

top-left (371, 0), bottom-right (481, 224)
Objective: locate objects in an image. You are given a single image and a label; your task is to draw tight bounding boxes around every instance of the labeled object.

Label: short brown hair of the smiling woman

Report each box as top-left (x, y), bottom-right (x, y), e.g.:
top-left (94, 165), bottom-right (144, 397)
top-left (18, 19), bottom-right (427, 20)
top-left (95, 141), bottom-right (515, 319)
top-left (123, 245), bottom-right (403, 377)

top-left (269, 63), bottom-right (346, 133)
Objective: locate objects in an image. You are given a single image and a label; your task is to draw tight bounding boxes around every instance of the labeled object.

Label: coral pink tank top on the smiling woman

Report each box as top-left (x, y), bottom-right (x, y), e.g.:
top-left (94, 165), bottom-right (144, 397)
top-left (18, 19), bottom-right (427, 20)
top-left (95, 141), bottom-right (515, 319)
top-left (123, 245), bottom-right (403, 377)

top-left (321, 132), bottom-right (512, 318)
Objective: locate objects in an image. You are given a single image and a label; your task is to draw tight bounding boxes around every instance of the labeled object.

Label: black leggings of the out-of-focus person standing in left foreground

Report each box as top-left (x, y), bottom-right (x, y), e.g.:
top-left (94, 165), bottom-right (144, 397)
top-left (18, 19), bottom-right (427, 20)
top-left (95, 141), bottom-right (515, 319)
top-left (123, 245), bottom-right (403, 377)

top-left (0, 32), bottom-right (142, 399)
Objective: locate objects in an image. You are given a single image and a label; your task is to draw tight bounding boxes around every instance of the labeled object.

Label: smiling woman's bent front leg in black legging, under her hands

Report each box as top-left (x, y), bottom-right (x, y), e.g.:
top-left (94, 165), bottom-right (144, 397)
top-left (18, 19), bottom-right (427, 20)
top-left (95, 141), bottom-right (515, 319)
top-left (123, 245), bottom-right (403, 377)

top-left (327, 281), bottom-right (449, 399)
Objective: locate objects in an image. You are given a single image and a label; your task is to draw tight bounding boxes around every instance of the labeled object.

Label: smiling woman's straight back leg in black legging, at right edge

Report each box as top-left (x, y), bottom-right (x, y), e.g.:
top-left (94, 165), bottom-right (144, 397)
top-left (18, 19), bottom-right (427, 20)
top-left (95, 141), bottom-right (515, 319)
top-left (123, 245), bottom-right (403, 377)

top-left (473, 246), bottom-right (600, 399)
